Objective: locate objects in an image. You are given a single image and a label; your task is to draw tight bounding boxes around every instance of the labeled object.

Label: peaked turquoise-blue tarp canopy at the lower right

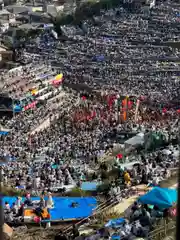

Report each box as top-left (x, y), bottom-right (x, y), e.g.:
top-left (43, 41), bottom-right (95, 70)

top-left (139, 187), bottom-right (177, 209)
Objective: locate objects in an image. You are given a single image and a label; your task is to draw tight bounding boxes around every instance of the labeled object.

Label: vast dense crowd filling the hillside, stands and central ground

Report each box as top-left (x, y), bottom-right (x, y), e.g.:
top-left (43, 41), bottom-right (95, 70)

top-left (0, 0), bottom-right (180, 238)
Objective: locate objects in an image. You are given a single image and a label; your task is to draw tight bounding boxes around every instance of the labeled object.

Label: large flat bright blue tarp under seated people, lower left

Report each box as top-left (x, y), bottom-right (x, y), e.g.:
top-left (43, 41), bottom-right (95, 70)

top-left (3, 197), bottom-right (97, 221)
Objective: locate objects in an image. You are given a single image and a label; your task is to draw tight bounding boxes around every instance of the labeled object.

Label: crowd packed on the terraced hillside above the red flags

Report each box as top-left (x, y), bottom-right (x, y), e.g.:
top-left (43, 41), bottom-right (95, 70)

top-left (19, 2), bottom-right (180, 101)
